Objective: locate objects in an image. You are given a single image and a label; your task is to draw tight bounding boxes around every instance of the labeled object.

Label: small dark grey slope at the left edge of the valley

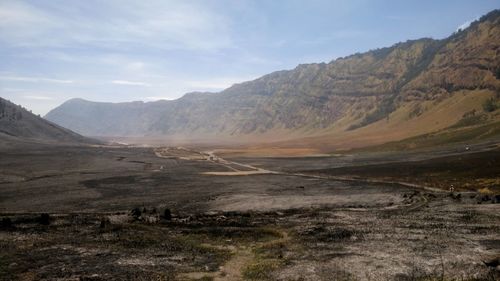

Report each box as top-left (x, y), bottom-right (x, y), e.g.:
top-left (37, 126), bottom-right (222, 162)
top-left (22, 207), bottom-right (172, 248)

top-left (0, 98), bottom-right (98, 144)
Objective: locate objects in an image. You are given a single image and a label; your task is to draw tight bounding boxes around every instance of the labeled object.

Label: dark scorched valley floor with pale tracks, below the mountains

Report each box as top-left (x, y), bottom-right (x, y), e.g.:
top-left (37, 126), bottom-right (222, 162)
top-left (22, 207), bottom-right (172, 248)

top-left (0, 143), bottom-right (500, 280)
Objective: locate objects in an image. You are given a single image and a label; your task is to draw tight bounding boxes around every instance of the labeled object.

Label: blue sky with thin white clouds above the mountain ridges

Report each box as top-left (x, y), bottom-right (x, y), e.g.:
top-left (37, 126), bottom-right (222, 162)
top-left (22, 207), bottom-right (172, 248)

top-left (0, 0), bottom-right (500, 115)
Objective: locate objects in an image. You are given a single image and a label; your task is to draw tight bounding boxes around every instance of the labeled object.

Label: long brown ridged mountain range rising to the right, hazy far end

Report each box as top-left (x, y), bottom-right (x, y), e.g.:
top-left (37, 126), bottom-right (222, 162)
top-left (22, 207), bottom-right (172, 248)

top-left (45, 10), bottom-right (500, 149)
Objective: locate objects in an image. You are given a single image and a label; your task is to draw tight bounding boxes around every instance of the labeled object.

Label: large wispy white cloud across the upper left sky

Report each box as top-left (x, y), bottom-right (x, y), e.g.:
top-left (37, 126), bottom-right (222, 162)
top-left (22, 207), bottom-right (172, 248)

top-left (0, 0), bottom-right (232, 50)
